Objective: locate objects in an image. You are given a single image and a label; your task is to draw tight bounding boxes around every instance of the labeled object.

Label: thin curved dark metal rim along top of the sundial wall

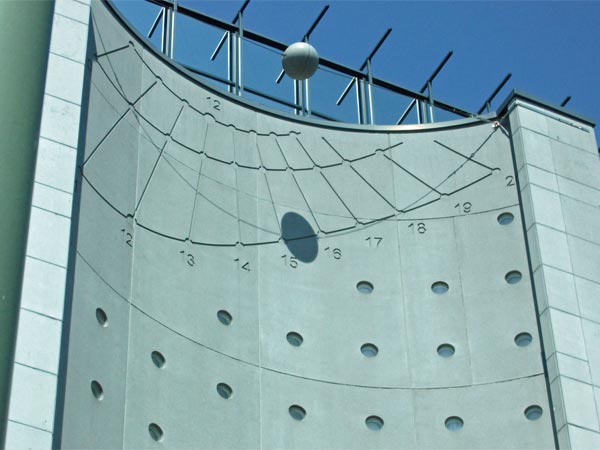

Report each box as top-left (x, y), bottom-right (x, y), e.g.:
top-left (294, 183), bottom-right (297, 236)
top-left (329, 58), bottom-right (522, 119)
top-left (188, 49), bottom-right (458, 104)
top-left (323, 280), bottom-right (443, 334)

top-left (101, 0), bottom-right (498, 133)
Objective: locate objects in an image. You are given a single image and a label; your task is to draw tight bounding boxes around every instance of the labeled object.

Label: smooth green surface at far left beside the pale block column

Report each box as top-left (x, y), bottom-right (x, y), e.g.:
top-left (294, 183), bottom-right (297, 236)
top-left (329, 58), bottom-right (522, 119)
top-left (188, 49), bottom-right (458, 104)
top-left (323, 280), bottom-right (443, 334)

top-left (0, 0), bottom-right (54, 442)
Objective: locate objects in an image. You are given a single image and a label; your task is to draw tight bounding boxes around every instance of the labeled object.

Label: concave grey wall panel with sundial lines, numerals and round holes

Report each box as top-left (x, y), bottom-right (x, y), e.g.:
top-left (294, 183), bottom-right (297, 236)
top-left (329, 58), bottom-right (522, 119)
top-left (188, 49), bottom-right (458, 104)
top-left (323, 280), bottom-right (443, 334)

top-left (62, 2), bottom-right (554, 449)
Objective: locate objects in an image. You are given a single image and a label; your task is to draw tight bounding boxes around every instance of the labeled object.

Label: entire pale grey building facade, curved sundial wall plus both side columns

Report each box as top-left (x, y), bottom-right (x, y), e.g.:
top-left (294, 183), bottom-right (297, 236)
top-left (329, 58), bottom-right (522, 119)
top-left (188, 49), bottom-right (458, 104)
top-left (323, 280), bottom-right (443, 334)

top-left (7, 1), bottom-right (600, 449)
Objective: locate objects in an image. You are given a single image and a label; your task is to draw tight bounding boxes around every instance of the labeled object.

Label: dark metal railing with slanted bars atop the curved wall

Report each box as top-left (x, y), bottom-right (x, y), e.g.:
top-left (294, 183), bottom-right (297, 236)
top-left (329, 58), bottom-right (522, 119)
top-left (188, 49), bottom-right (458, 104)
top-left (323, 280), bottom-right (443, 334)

top-left (129, 0), bottom-right (510, 124)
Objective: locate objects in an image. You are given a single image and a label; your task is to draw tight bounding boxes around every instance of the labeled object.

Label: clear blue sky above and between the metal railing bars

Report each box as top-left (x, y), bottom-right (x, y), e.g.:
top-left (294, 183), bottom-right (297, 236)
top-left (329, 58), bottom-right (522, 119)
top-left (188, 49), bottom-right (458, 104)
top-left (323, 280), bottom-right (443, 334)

top-left (116, 0), bottom-right (600, 140)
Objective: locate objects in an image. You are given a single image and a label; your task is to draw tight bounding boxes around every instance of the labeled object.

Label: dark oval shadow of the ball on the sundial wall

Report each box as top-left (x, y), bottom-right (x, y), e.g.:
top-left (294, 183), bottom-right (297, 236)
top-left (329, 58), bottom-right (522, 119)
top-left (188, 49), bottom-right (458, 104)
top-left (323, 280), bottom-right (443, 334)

top-left (281, 212), bottom-right (319, 263)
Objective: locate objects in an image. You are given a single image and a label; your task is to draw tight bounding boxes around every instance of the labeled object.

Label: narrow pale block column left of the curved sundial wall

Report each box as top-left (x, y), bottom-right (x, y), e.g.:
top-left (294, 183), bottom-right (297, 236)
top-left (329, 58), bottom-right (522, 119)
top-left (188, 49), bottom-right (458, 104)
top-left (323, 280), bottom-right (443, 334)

top-left (6, 0), bottom-right (90, 449)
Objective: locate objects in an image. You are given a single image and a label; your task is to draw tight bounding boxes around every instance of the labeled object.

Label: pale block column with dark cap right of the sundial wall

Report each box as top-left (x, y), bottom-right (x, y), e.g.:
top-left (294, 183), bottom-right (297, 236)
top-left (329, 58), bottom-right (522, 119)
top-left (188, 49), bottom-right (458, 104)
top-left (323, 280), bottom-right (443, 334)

top-left (508, 97), bottom-right (600, 449)
